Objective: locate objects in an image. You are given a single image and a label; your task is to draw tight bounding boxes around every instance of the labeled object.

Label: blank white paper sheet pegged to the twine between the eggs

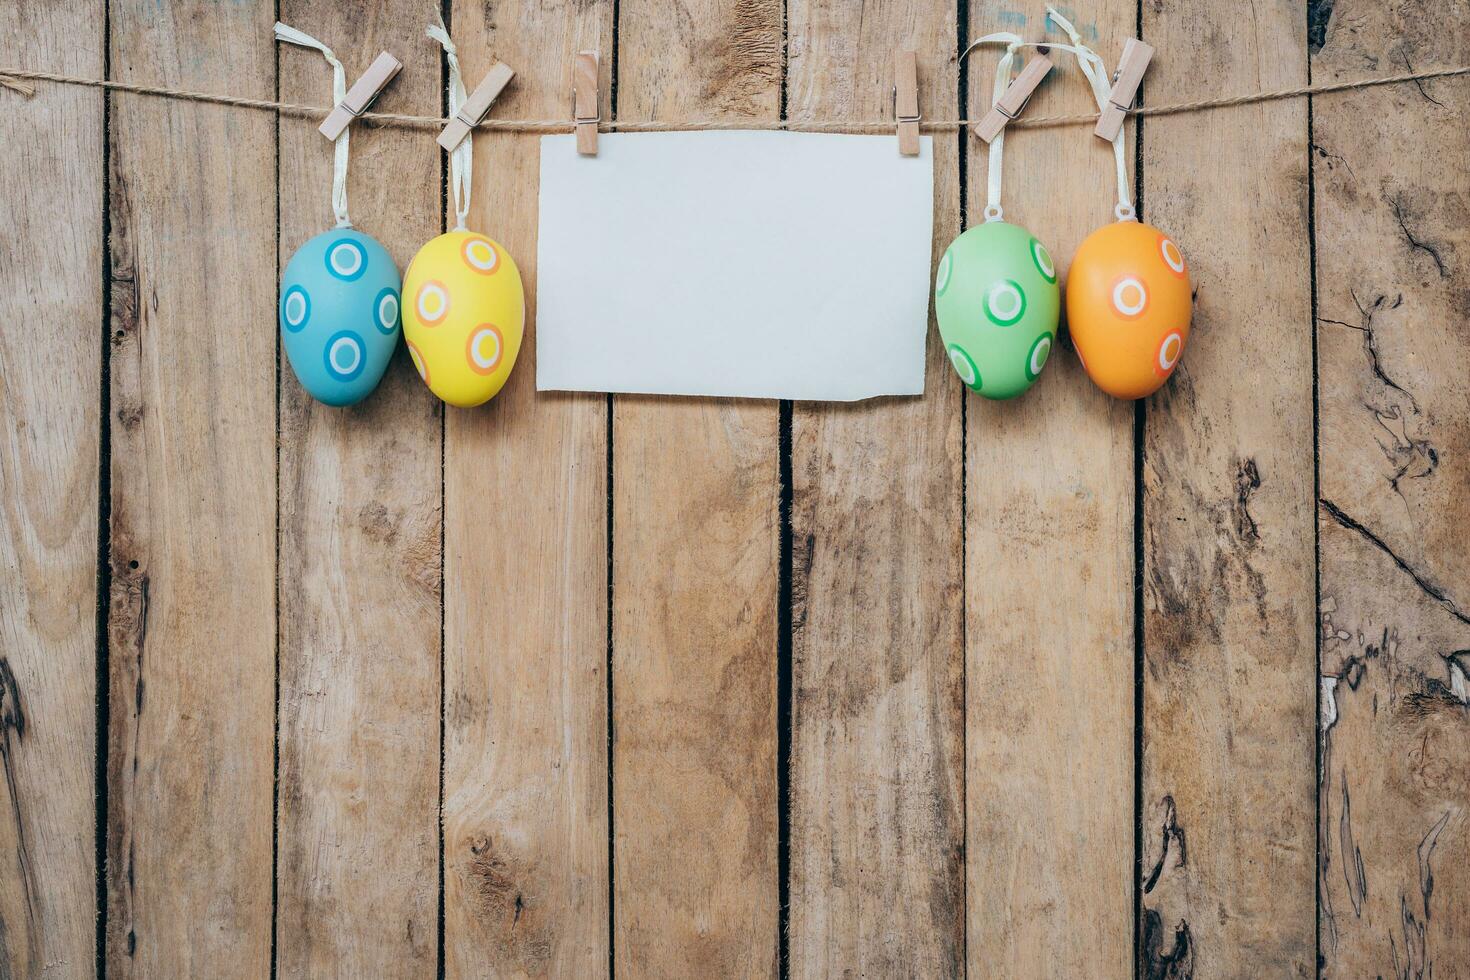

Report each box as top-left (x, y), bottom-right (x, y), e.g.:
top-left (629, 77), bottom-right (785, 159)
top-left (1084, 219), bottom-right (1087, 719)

top-left (535, 132), bottom-right (933, 401)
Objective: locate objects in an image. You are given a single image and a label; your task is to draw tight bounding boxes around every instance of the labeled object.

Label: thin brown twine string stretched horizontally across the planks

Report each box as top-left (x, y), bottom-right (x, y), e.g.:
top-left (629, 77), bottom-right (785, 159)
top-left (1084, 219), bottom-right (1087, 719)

top-left (0, 65), bottom-right (1470, 134)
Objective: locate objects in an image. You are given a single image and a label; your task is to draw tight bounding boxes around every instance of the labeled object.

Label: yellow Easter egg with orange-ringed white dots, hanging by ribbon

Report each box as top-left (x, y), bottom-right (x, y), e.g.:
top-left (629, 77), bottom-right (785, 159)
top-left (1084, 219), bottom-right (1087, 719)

top-left (403, 231), bottom-right (526, 408)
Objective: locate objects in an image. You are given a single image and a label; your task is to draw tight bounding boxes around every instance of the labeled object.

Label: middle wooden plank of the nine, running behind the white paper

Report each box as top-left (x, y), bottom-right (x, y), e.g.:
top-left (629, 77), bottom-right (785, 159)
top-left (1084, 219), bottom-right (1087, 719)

top-left (613, 0), bottom-right (784, 977)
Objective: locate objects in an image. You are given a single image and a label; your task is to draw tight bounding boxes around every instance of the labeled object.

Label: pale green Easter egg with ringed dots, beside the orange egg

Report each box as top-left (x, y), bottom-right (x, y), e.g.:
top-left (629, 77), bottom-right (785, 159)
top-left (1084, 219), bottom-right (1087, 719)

top-left (933, 220), bottom-right (1061, 398)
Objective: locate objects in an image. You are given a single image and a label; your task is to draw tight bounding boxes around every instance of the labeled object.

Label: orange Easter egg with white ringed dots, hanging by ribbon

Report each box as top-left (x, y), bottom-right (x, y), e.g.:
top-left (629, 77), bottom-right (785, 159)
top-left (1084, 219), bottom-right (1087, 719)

top-left (1067, 220), bottom-right (1192, 398)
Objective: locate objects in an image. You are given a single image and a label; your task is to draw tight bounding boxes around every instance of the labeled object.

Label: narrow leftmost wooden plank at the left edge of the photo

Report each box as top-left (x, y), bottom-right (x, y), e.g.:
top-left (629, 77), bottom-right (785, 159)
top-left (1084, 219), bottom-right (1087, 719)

top-left (0, 0), bottom-right (104, 977)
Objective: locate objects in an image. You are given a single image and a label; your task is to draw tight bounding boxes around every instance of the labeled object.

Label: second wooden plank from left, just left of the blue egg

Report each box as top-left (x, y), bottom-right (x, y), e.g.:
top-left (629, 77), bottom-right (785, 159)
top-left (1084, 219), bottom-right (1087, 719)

top-left (107, 0), bottom-right (278, 977)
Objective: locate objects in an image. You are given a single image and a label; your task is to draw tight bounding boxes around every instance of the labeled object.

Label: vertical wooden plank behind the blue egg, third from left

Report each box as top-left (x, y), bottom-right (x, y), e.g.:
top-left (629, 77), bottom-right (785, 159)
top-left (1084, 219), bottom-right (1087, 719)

top-left (273, 0), bottom-right (442, 977)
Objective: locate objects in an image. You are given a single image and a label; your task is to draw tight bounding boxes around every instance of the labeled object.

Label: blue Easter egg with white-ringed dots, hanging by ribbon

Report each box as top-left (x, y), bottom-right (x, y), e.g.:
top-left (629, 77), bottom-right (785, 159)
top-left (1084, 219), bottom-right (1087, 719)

top-left (281, 228), bottom-right (400, 406)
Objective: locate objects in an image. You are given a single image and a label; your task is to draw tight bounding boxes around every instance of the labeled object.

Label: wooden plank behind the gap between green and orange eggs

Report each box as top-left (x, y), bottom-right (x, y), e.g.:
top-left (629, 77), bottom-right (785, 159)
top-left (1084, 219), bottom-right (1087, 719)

top-left (964, 0), bottom-right (1136, 977)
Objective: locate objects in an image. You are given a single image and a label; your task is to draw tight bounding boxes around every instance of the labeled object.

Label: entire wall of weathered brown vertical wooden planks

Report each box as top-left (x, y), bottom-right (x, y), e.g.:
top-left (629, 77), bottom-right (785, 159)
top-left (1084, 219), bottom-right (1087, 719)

top-left (0, 0), bottom-right (1470, 979)
